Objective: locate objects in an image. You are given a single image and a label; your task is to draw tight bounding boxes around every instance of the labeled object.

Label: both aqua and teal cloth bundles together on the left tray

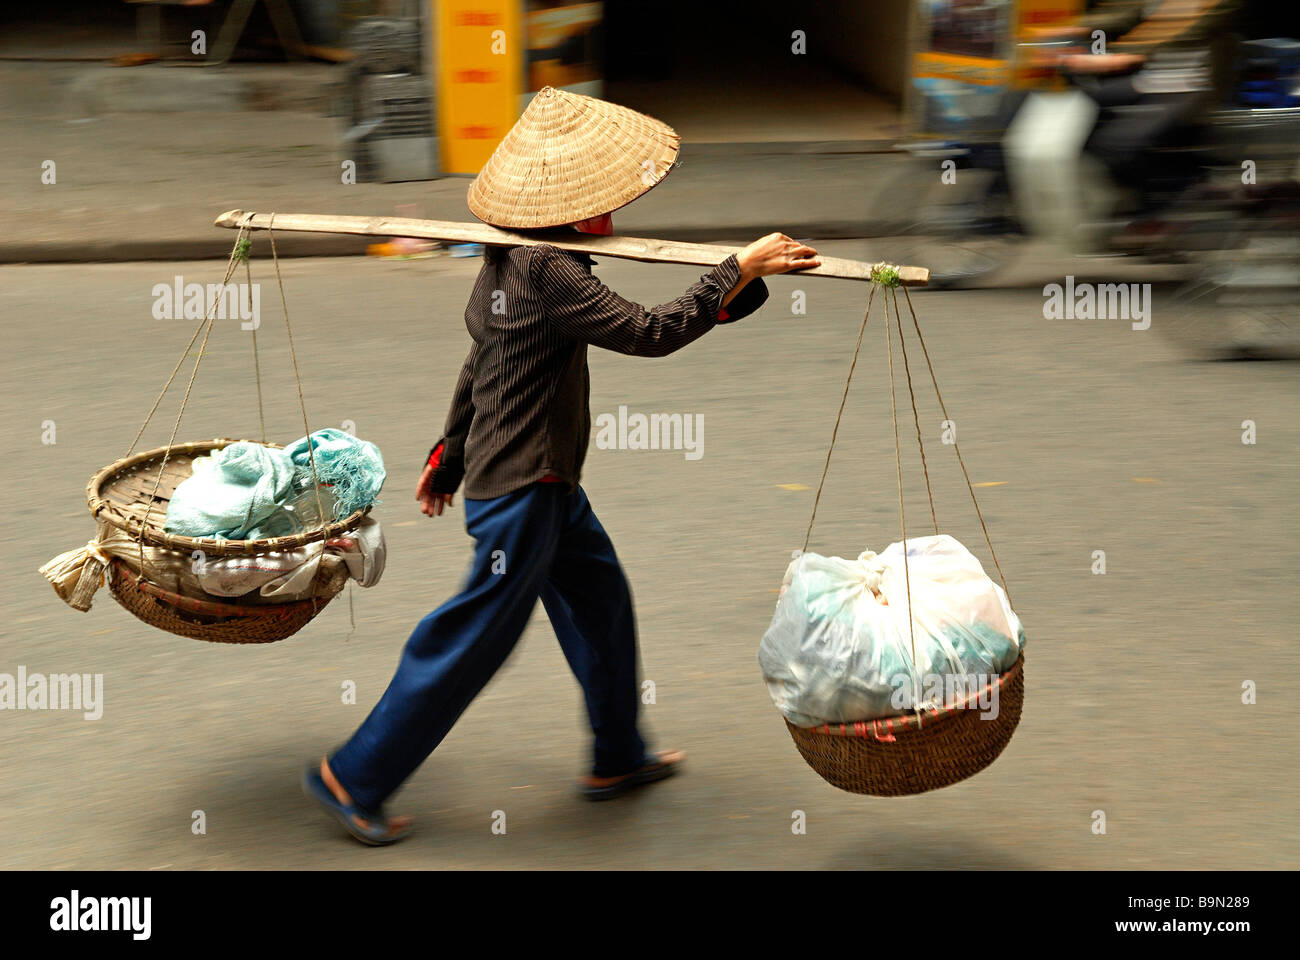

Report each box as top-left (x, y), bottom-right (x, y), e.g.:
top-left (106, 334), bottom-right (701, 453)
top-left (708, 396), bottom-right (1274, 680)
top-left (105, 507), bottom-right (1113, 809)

top-left (164, 427), bottom-right (387, 540)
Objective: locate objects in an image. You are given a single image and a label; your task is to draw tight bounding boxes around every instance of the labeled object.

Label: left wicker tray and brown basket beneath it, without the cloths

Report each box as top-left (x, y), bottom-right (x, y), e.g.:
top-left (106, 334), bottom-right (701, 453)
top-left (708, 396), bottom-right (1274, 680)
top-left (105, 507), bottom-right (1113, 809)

top-left (86, 438), bottom-right (368, 644)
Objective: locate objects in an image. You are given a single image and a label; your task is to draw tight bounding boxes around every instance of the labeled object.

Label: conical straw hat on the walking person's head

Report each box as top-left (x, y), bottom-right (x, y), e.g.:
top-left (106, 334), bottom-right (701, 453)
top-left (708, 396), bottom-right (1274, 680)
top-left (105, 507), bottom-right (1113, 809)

top-left (468, 87), bottom-right (681, 228)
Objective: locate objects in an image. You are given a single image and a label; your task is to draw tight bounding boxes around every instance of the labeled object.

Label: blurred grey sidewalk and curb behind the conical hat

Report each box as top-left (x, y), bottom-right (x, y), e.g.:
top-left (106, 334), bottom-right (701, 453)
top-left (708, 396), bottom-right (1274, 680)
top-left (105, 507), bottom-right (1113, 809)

top-left (0, 62), bottom-right (928, 263)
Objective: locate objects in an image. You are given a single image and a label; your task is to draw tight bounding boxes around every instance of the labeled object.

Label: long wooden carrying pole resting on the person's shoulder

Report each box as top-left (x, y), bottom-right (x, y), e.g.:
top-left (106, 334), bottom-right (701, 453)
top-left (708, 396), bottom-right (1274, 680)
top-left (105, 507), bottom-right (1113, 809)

top-left (215, 209), bottom-right (930, 286)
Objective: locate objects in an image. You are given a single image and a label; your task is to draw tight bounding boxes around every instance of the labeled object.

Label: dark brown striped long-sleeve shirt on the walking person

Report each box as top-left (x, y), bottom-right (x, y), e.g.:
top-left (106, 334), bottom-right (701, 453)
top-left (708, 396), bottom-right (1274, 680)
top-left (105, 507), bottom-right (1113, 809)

top-left (432, 243), bottom-right (767, 500)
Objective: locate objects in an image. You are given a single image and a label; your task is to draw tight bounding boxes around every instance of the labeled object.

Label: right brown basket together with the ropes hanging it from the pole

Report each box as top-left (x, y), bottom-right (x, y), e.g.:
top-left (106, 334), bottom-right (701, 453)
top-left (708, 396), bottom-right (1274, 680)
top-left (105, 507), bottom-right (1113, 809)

top-left (785, 264), bottom-right (1024, 796)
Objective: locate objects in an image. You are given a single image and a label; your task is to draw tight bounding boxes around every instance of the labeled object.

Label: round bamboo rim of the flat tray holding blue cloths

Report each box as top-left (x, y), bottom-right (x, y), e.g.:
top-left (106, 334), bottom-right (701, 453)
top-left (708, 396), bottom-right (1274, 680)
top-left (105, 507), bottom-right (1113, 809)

top-left (86, 437), bottom-right (371, 557)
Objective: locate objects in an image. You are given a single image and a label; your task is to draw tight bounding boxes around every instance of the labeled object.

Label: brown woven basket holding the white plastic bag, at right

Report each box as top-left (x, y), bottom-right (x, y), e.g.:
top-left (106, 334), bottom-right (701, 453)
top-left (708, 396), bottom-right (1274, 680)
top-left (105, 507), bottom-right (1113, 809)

top-left (785, 653), bottom-right (1024, 796)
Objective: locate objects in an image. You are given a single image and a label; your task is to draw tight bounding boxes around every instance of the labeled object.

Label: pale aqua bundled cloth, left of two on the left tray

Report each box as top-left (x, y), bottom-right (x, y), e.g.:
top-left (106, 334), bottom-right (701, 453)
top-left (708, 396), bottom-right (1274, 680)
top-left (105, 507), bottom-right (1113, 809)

top-left (164, 441), bottom-right (295, 540)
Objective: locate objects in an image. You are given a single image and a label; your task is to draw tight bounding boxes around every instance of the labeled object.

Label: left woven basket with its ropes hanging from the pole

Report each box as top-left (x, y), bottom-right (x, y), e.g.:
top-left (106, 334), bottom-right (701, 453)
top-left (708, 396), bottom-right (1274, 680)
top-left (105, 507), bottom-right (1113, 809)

top-left (42, 221), bottom-right (369, 644)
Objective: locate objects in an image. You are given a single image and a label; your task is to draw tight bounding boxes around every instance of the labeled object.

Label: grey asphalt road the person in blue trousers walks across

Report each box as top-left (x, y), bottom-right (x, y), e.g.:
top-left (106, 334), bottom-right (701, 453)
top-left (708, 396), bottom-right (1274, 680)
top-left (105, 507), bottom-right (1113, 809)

top-left (0, 248), bottom-right (1300, 869)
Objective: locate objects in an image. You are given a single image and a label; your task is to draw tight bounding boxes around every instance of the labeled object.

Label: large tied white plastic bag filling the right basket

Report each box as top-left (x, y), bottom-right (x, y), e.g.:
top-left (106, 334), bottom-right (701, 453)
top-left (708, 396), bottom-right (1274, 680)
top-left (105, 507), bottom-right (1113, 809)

top-left (758, 535), bottom-right (1024, 727)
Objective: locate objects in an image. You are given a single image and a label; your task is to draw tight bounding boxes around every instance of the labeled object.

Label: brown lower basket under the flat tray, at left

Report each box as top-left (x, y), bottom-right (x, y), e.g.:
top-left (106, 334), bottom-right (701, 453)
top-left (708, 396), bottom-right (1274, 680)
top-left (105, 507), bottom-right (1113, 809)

top-left (109, 561), bottom-right (333, 644)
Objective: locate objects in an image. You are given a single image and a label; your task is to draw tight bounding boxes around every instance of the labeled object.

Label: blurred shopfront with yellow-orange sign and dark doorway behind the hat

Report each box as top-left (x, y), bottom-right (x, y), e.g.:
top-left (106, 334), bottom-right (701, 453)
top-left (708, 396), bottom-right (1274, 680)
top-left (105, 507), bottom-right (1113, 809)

top-left (0, 0), bottom-right (913, 178)
